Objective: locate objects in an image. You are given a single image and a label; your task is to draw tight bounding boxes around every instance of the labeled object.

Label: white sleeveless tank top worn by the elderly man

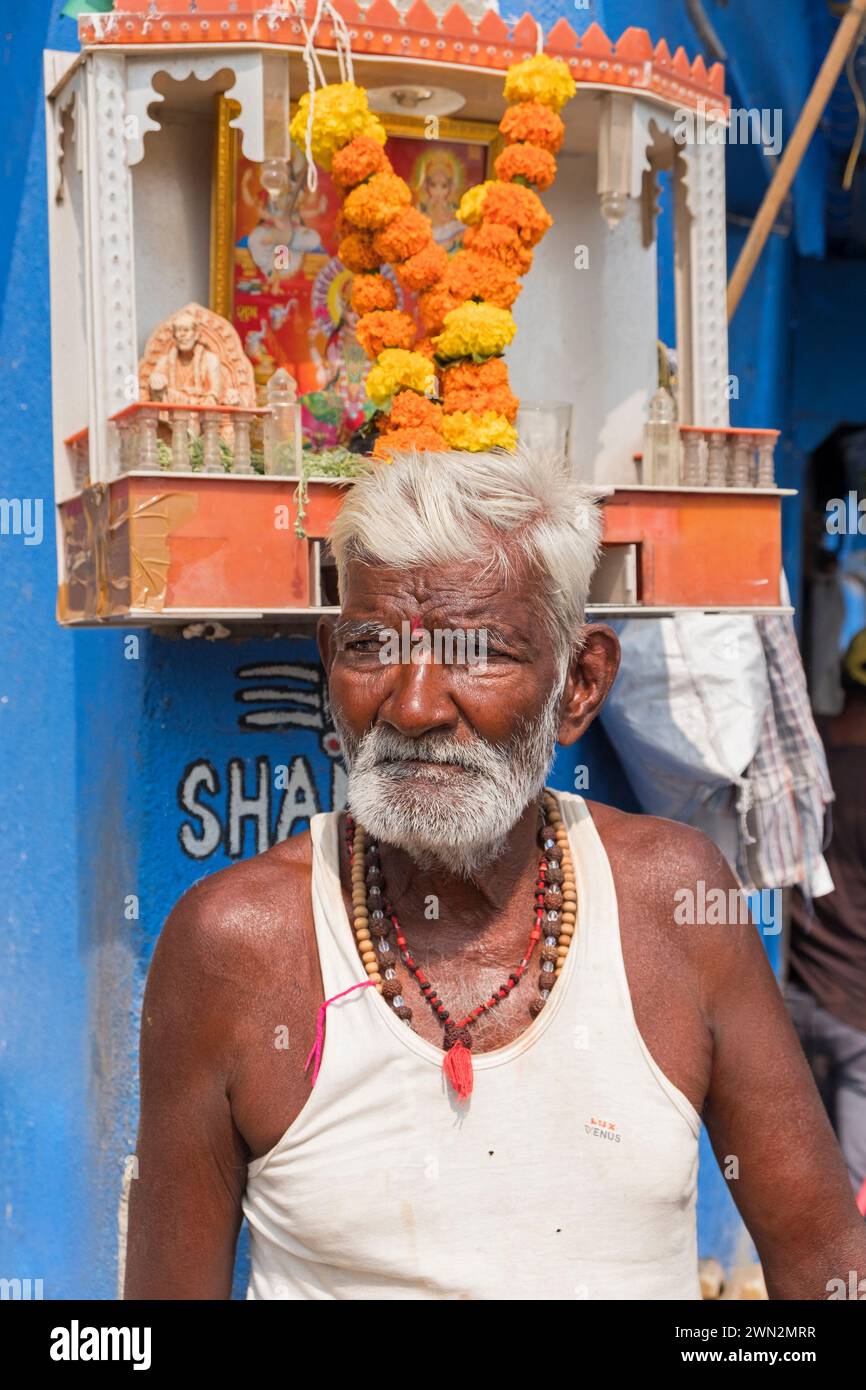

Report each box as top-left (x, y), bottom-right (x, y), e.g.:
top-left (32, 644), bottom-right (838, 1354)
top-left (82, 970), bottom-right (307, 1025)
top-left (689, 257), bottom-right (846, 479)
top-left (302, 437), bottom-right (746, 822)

top-left (243, 792), bottom-right (701, 1301)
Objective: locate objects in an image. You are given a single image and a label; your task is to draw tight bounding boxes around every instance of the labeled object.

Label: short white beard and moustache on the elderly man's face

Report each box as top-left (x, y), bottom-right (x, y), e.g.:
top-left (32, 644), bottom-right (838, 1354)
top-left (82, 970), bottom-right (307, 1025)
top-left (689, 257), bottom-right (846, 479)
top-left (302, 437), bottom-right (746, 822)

top-left (332, 666), bottom-right (567, 878)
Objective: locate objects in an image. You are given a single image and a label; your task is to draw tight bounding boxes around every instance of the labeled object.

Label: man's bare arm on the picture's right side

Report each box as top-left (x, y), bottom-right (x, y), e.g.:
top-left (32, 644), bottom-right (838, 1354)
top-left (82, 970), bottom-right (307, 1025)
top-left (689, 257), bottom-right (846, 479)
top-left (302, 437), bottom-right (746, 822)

top-left (695, 842), bottom-right (866, 1298)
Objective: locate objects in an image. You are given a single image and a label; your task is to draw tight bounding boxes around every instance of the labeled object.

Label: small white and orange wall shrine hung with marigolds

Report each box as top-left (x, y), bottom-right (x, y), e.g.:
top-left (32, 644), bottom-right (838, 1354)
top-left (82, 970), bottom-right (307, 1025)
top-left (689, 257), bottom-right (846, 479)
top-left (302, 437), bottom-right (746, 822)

top-left (46, 0), bottom-right (785, 626)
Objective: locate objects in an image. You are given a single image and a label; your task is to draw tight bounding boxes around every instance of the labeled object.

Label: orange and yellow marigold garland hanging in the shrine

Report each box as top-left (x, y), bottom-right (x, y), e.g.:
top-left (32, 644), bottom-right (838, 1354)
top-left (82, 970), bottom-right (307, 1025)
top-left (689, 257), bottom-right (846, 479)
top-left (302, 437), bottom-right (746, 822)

top-left (292, 53), bottom-right (575, 460)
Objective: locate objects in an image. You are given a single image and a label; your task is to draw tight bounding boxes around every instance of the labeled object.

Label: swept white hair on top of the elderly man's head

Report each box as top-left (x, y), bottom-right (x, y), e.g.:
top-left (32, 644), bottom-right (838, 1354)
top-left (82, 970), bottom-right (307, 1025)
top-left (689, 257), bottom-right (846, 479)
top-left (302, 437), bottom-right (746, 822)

top-left (329, 445), bottom-right (601, 651)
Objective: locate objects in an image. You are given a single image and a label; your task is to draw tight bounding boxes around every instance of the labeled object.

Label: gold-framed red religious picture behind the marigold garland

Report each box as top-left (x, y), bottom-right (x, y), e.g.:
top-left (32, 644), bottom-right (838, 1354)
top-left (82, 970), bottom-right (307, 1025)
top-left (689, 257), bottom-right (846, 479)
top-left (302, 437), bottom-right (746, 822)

top-left (211, 96), bottom-right (499, 449)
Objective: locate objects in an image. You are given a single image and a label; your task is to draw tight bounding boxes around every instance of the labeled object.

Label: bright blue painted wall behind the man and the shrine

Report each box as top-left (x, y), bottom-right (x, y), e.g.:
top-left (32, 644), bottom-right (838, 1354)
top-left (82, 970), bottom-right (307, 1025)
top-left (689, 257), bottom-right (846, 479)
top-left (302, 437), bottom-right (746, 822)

top-left (0, 0), bottom-right (845, 1298)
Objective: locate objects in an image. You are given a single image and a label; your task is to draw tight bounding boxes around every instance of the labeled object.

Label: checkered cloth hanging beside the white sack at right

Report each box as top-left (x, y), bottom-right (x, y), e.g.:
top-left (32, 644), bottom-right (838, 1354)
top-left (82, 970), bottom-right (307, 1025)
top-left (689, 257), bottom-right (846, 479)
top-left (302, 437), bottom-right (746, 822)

top-left (737, 616), bottom-right (833, 898)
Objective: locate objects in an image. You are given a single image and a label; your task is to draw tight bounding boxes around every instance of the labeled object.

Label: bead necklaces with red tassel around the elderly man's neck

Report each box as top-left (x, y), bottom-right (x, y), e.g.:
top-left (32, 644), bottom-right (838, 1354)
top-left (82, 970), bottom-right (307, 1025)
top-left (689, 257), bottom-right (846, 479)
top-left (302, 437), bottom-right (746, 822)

top-left (346, 791), bottom-right (577, 1101)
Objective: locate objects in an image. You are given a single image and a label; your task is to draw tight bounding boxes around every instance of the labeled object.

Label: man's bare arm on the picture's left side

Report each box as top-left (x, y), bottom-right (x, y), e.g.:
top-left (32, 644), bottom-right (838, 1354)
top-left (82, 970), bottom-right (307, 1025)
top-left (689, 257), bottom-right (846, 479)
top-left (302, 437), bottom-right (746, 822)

top-left (124, 880), bottom-right (247, 1298)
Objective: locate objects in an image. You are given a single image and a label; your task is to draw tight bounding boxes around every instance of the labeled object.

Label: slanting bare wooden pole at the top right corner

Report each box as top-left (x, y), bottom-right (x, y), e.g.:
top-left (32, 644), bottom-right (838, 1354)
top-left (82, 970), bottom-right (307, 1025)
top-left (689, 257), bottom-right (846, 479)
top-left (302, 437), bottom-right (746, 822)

top-left (727, 0), bottom-right (866, 322)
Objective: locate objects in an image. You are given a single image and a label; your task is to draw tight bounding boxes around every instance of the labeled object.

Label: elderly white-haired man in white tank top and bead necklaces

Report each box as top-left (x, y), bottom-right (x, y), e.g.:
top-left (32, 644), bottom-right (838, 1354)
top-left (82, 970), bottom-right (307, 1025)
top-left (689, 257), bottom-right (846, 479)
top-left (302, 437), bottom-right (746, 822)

top-left (126, 452), bottom-right (866, 1300)
